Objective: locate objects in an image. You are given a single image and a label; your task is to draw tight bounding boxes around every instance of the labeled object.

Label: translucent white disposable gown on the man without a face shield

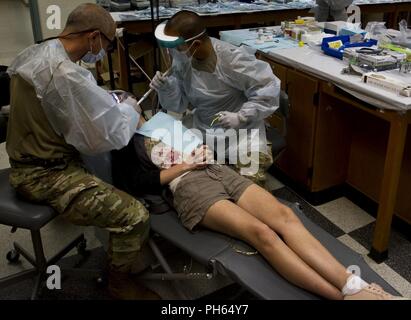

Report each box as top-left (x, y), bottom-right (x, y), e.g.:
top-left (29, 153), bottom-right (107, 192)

top-left (8, 39), bottom-right (140, 155)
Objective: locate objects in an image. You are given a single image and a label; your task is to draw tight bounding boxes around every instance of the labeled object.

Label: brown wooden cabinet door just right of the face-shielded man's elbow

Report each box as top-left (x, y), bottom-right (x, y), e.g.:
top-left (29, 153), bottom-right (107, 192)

top-left (277, 69), bottom-right (318, 189)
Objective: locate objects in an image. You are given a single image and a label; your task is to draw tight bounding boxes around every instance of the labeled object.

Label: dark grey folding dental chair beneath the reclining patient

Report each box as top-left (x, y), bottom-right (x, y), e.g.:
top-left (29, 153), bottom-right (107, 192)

top-left (83, 154), bottom-right (398, 300)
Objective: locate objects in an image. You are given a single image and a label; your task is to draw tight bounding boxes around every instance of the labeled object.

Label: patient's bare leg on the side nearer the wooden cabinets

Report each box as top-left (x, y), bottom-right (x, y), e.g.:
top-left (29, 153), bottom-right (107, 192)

top-left (238, 185), bottom-right (349, 290)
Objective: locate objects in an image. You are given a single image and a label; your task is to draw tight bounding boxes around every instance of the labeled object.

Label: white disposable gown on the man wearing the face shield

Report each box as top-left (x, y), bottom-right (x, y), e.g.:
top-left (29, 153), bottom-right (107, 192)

top-left (158, 38), bottom-right (280, 156)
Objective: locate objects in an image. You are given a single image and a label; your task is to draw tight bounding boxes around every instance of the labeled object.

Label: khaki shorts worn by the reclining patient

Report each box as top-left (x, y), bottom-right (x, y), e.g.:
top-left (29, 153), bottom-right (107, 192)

top-left (174, 165), bottom-right (253, 231)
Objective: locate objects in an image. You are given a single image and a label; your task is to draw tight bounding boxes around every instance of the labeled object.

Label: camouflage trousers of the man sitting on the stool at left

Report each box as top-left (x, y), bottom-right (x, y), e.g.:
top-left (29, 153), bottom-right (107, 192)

top-left (10, 161), bottom-right (149, 272)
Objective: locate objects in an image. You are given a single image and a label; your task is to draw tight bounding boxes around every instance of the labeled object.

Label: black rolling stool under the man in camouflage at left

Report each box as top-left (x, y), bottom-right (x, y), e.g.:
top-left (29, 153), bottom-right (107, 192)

top-left (0, 169), bottom-right (100, 300)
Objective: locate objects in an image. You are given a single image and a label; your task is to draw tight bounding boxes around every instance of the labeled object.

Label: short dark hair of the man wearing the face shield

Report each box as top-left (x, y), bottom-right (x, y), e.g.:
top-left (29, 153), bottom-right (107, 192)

top-left (164, 10), bottom-right (207, 40)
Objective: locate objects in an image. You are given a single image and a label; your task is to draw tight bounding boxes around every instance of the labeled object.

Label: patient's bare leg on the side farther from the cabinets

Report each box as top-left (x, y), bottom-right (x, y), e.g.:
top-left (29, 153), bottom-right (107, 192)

top-left (201, 200), bottom-right (342, 299)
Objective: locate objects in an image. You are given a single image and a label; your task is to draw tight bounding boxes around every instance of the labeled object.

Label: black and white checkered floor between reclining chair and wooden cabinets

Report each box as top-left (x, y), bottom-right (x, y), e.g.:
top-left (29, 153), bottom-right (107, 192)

top-left (274, 182), bottom-right (411, 298)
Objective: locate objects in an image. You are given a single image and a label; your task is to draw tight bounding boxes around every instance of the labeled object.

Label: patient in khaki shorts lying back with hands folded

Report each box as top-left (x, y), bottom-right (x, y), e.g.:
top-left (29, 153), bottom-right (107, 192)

top-left (113, 134), bottom-right (402, 300)
